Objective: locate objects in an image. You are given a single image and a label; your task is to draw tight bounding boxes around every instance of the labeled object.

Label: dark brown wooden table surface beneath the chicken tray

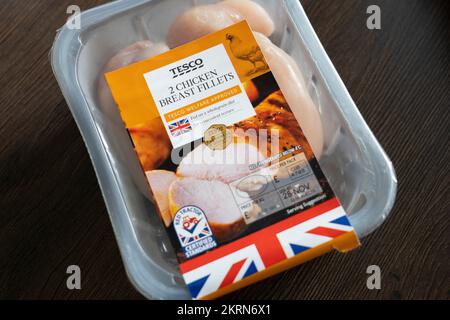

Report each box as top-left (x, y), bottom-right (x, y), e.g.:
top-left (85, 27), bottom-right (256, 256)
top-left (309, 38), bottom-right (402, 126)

top-left (0, 0), bottom-right (450, 299)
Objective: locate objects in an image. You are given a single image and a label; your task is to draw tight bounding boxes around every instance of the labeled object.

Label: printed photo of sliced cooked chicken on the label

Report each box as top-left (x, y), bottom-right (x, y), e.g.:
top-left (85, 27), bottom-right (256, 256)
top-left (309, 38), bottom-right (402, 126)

top-left (142, 72), bottom-right (332, 261)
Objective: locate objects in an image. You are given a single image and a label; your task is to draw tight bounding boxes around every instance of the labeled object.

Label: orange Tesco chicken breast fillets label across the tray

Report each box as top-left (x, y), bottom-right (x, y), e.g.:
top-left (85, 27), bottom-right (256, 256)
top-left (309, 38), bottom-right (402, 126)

top-left (106, 21), bottom-right (359, 299)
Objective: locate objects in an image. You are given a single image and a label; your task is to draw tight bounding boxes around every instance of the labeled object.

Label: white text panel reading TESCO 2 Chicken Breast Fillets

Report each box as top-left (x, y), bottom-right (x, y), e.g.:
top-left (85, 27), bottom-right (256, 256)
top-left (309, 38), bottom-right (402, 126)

top-left (144, 44), bottom-right (255, 148)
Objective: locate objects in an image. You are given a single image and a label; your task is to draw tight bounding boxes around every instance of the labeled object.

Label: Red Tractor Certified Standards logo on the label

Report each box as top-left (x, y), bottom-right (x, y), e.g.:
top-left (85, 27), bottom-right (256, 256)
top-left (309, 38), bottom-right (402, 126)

top-left (174, 206), bottom-right (217, 258)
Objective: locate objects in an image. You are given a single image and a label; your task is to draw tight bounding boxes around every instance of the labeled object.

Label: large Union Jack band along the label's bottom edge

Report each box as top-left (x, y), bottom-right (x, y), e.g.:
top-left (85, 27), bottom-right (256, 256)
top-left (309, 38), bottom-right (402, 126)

top-left (180, 199), bottom-right (354, 299)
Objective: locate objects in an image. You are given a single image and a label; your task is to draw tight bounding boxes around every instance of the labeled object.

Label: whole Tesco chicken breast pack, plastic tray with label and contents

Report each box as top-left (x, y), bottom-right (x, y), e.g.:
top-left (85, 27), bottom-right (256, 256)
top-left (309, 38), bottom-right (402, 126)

top-left (52, 0), bottom-right (396, 299)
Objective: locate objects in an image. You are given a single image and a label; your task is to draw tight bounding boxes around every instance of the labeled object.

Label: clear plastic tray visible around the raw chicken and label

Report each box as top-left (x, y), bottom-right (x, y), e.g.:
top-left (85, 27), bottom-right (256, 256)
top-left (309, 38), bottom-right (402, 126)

top-left (51, 0), bottom-right (397, 299)
